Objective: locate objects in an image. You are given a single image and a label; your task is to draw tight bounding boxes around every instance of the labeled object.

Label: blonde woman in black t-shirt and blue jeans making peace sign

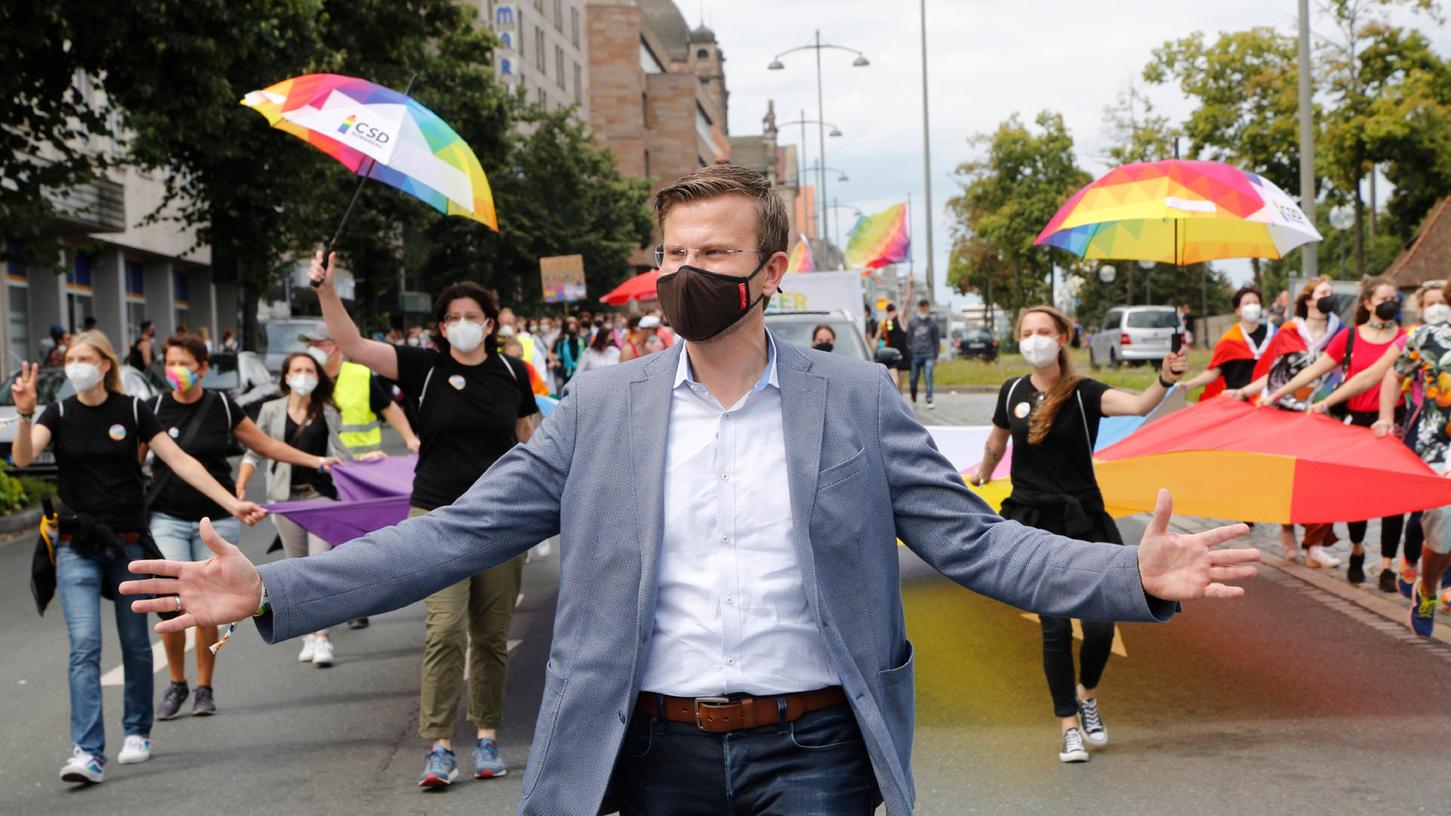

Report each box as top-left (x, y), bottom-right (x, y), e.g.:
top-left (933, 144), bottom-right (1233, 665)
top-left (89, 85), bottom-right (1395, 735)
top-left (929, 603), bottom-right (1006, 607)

top-left (10, 331), bottom-right (264, 783)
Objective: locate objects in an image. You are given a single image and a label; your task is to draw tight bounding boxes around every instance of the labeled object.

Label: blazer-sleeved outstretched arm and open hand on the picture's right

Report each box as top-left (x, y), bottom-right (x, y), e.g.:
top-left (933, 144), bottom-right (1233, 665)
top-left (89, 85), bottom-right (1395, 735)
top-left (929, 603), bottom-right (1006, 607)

top-left (878, 367), bottom-right (1259, 620)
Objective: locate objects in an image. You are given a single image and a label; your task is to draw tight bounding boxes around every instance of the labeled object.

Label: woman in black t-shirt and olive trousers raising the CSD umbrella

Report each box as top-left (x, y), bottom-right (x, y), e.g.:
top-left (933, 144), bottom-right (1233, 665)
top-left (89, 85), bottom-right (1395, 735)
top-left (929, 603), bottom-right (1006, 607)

top-left (312, 253), bottom-right (538, 787)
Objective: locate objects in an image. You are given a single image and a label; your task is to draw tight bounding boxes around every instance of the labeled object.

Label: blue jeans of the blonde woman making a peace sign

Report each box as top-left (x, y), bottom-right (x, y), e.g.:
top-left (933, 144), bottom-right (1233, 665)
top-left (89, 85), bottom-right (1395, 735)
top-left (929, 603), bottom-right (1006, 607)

top-left (55, 544), bottom-right (154, 762)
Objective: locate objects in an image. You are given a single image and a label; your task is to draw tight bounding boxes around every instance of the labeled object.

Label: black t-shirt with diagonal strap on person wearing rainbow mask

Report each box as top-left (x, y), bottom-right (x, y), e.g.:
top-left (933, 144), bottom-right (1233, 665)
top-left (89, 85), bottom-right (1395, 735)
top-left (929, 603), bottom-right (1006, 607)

top-left (149, 391), bottom-right (247, 521)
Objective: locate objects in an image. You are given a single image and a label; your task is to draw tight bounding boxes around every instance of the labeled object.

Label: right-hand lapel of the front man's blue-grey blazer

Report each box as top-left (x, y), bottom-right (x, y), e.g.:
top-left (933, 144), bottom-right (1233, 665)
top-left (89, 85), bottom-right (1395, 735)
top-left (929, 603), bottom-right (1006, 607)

top-left (776, 341), bottom-right (827, 619)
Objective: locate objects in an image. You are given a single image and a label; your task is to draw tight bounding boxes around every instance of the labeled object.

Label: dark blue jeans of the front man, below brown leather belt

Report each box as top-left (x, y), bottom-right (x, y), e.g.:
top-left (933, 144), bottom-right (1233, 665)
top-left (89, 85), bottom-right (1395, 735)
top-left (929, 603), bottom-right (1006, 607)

top-left (611, 706), bottom-right (882, 816)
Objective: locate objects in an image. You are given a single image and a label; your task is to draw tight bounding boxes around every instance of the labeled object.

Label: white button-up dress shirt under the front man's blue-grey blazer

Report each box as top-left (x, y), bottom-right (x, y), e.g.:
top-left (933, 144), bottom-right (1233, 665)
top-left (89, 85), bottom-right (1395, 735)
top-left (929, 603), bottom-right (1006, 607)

top-left (640, 332), bottom-right (840, 697)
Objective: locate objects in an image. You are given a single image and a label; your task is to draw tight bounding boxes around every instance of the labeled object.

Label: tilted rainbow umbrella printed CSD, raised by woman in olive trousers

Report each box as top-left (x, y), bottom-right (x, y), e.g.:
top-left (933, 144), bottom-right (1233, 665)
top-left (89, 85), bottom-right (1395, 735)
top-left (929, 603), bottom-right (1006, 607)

top-left (242, 74), bottom-right (499, 254)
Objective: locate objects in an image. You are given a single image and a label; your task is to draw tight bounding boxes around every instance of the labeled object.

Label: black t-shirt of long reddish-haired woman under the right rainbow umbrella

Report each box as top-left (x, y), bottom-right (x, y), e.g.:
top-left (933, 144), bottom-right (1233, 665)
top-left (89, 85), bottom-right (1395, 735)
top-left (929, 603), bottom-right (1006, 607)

top-left (992, 378), bottom-right (1109, 495)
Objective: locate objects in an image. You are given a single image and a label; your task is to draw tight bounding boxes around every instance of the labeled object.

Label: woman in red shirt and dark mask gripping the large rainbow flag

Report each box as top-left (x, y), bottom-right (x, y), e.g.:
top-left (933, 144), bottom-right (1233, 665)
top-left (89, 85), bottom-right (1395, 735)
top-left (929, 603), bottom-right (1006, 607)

top-left (1262, 277), bottom-right (1406, 584)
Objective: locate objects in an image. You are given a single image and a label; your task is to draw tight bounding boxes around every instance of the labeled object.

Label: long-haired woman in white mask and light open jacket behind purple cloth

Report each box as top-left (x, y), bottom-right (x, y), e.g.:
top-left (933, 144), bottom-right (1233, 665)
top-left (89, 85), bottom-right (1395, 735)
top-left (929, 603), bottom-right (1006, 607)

top-left (237, 351), bottom-right (353, 668)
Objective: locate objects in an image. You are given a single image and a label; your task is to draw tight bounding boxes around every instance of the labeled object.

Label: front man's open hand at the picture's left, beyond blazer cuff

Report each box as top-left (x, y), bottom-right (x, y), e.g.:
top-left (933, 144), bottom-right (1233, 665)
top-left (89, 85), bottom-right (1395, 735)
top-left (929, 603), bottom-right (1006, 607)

top-left (120, 518), bottom-right (263, 635)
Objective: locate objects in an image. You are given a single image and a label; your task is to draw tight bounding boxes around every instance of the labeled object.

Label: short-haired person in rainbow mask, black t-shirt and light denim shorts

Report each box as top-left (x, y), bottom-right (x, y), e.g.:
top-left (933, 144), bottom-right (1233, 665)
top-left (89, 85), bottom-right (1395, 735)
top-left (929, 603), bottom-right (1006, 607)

top-left (149, 334), bottom-right (334, 720)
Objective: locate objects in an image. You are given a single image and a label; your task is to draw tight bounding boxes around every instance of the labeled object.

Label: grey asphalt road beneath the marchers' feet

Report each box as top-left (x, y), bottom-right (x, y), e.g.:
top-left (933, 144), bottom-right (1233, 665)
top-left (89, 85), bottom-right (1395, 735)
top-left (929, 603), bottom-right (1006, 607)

top-left (0, 395), bottom-right (1451, 816)
